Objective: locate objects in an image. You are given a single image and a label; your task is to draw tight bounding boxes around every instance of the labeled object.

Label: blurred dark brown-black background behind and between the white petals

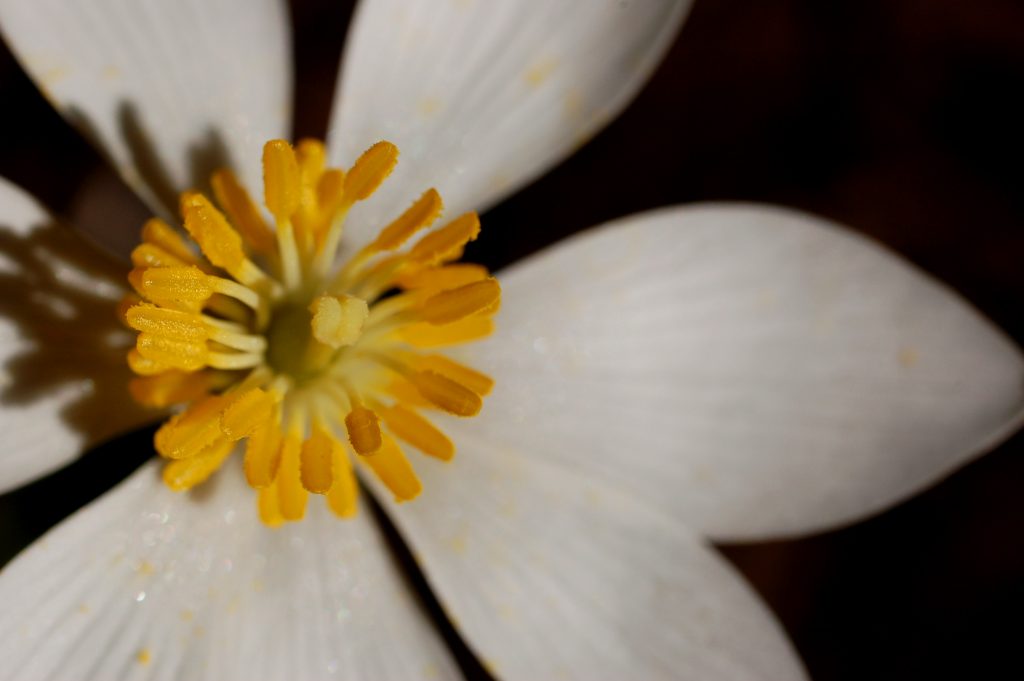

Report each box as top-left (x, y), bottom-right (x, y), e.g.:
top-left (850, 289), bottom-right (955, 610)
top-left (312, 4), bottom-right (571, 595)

top-left (0, 0), bottom-right (1024, 681)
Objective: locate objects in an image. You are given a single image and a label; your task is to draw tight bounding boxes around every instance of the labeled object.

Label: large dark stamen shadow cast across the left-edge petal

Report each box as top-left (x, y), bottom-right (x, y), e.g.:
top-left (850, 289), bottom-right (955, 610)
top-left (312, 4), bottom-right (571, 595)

top-left (0, 213), bottom-right (155, 456)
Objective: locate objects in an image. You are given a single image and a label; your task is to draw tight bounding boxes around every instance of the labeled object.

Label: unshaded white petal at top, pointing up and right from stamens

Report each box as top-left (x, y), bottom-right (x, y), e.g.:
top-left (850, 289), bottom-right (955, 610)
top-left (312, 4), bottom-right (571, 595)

top-left (329, 0), bottom-right (690, 250)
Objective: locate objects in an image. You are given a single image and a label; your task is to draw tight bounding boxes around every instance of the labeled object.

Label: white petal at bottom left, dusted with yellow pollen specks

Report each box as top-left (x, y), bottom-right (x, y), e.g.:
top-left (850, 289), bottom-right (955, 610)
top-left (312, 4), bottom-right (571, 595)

top-left (0, 461), bottom-right (458, 680)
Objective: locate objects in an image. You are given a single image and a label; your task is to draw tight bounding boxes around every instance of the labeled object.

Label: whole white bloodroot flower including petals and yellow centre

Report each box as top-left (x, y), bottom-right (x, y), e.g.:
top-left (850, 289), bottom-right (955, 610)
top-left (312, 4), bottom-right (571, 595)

top-left (0, 0), bottom-right (1024, 681)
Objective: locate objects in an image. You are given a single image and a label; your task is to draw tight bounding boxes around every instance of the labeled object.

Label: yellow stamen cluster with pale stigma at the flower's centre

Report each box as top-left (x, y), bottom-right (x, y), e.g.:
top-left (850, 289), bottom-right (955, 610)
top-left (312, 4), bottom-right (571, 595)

top-left (120, 135), bottom-right (501, 526)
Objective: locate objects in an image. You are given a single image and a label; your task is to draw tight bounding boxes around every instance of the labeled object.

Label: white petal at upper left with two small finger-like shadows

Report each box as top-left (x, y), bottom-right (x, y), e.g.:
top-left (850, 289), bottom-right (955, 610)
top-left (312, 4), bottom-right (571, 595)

top-left (0, 0), bottom-right (292, 228)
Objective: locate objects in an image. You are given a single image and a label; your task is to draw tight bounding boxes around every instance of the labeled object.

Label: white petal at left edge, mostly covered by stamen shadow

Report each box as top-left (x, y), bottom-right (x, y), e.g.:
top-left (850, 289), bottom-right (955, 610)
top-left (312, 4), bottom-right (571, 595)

top-left (0, 178), bottom-right (154, 492)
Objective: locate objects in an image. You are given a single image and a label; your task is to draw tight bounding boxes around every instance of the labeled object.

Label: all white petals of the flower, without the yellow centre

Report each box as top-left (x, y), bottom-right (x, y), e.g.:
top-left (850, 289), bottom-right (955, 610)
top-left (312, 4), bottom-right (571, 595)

top-left (0, 0), bottom-right (1024, 679)
